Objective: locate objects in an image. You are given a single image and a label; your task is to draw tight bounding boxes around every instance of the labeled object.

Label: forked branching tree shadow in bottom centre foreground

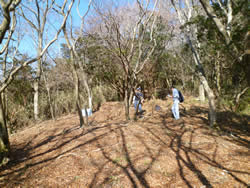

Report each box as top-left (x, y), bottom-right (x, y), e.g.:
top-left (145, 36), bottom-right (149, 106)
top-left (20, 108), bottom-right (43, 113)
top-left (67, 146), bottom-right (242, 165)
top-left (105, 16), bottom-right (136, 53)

top-left (89, 123), bottom-right (162, 188)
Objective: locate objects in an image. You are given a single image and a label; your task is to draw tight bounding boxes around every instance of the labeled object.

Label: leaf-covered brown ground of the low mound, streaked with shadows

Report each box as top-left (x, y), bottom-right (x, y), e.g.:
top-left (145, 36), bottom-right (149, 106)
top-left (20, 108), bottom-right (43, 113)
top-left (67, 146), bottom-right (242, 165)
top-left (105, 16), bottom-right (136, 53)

top-left (0, 101), bottom-right (250, 188)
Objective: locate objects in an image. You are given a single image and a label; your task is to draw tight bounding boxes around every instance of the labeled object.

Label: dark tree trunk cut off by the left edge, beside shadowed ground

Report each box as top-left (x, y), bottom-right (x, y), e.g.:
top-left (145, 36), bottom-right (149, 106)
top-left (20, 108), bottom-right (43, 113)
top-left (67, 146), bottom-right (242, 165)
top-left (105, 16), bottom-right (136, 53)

top-left (0, 93), bottom-right (10, 166)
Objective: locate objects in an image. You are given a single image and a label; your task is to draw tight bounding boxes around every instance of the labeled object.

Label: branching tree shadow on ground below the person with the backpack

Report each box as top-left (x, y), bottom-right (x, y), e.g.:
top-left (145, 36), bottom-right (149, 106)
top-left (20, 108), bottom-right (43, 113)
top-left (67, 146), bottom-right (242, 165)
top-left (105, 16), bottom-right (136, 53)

top-left (158, 115), bottom-right (250, 187)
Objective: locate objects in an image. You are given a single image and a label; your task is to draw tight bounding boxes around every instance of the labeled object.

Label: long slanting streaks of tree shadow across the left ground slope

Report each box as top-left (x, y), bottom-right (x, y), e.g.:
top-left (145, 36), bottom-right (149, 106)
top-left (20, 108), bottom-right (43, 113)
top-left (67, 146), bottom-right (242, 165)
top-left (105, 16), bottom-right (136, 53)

top-left (0, 124), bottom-right (121, 187)
